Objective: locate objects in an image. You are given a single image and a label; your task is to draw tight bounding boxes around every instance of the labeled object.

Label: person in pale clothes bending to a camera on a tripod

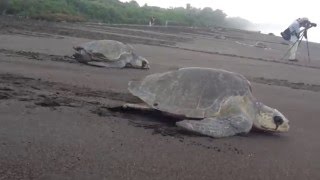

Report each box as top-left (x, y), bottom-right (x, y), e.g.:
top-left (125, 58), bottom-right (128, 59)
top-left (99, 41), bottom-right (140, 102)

top-left (281, 18), bottom-right (317, 61)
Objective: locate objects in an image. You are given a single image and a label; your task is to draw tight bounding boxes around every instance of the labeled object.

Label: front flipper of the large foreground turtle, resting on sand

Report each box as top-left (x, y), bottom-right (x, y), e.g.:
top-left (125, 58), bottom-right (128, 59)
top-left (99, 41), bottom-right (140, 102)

top-left (176, 114), bottom-right (253, 138)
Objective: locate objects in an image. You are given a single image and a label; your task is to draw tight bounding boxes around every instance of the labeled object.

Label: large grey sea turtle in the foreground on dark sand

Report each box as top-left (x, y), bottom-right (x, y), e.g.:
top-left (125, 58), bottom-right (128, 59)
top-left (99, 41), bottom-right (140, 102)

top-left (121, 67), bottom-right (289, 138)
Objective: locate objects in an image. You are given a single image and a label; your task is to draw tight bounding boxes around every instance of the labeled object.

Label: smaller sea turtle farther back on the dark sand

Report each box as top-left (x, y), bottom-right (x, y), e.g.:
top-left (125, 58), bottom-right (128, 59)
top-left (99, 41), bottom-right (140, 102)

top-left (73, 40), bottom-right (150, 69)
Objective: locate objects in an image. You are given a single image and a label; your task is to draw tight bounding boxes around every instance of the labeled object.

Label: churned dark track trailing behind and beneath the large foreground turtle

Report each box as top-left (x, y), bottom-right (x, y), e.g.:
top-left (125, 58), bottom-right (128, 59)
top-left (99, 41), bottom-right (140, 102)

top-left (0, 74), bottom-right (248, 155)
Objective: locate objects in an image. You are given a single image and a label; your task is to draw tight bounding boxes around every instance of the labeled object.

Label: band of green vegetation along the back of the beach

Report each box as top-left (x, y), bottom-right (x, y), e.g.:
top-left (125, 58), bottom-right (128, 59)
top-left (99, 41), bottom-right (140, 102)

top-left (0, 0), bottom-right (254, 28)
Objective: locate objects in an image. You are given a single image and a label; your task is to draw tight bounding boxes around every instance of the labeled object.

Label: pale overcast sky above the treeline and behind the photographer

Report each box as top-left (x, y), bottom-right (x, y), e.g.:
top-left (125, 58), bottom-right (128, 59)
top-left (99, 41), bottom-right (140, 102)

top-left (121, 0), bottom-right (320, 42)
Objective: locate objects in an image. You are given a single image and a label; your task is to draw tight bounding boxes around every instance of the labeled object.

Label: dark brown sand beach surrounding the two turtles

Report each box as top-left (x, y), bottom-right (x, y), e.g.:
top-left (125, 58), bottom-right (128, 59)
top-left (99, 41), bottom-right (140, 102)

top-left (0, 17), bottom-right (320, 180)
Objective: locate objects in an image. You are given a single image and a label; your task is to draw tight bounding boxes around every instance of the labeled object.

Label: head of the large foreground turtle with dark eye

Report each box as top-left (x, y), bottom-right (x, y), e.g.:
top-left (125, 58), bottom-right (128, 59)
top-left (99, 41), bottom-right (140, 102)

top-left (253, 102), bottom-right (289, 132)
